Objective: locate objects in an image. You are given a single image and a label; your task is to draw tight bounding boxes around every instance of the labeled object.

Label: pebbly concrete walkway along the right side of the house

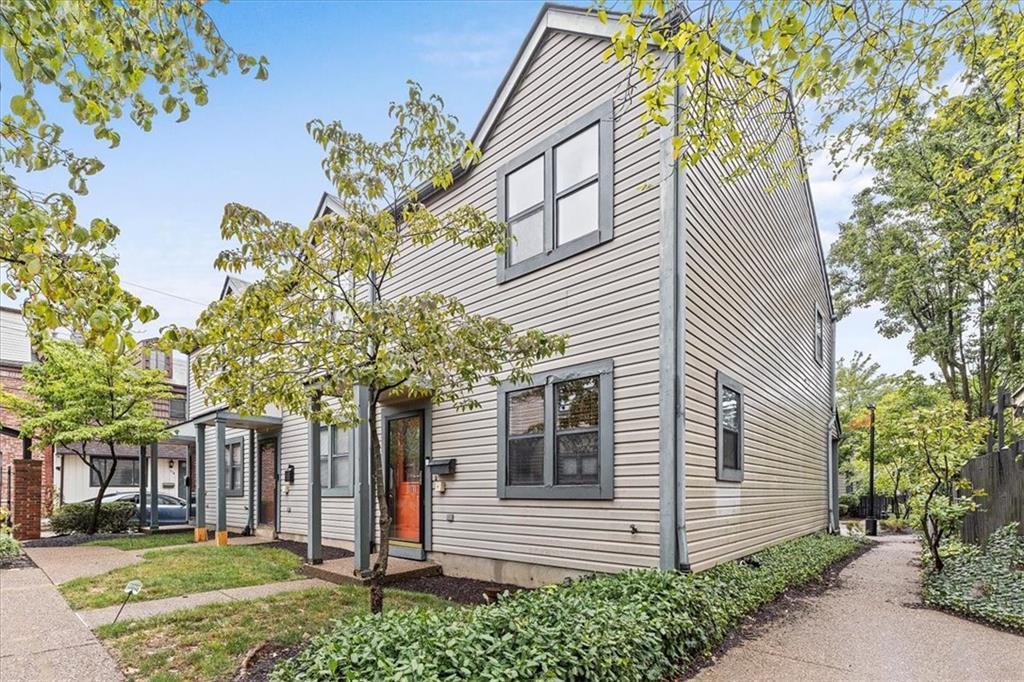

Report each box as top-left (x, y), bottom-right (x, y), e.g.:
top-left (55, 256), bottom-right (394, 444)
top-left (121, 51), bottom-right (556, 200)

top-left (696, 537), bottom-right (1024, 682)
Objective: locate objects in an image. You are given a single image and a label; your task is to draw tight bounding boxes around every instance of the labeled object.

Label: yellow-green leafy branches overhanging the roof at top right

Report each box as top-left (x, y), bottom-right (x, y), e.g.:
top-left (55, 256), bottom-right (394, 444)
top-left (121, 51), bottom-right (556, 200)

top-left (597, 0), bottom-right (1024, 268)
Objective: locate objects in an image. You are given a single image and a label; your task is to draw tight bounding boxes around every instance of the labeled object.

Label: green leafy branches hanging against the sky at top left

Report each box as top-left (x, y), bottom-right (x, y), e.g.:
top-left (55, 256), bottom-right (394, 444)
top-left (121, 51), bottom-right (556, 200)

top-left (0, 0), bottom-right (267, 350)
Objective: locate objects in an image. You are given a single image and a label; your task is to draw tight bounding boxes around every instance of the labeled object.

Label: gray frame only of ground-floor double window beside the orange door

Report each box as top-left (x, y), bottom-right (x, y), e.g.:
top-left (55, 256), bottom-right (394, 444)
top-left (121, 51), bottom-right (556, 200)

top-left (497, 358), bottom-right (614, 500)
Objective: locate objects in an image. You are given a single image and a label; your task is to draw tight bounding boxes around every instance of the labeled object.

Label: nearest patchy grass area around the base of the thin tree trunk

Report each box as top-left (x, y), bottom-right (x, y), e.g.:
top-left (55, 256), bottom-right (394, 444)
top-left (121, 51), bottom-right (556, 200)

top-left (96, 585), bottom-right (451, 682)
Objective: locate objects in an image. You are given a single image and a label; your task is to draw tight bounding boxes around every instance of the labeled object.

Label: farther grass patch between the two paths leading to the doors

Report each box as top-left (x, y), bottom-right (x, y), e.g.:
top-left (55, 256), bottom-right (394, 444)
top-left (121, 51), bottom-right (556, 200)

top-left (60, 546), bottom-right (301, 609)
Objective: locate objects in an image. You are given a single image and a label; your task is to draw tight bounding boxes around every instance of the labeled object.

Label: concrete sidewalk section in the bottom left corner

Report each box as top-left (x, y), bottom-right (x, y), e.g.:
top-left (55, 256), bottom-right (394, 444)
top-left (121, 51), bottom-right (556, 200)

top-left (0, 568), bottom-right (124, 682)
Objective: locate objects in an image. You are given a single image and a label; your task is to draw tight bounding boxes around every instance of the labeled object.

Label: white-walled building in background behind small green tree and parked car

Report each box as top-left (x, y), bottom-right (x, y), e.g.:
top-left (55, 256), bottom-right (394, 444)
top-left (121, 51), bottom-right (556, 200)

top-left (55, 339), bottom-right (194, 503)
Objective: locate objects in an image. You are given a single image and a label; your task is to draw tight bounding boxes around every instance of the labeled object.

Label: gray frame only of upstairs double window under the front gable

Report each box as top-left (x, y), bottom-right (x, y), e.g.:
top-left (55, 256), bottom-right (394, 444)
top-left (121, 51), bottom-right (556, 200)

top-left (497, 99), bottom-right (614, 284)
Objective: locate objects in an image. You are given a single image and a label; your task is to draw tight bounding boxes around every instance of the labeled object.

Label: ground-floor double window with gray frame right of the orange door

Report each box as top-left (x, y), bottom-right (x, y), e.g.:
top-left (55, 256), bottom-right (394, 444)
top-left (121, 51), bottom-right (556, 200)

top-left (498, 360), bottom-right (613, 500)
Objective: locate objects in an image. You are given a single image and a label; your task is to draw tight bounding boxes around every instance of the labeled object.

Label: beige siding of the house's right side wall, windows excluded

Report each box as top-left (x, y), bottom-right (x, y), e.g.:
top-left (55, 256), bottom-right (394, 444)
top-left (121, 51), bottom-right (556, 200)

top-left (685, 111), bottom-right (833, 569)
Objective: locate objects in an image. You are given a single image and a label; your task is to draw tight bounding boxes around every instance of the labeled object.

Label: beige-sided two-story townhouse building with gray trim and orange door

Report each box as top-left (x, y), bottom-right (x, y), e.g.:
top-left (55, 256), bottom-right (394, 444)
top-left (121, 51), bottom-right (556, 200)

top-left (180, 6), bottom-right (838, 585)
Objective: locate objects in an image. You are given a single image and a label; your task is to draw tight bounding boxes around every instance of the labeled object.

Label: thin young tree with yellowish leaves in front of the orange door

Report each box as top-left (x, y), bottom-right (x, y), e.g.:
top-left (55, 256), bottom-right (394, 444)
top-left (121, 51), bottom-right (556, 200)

top-left (167, 83), bottom-right (565, 612)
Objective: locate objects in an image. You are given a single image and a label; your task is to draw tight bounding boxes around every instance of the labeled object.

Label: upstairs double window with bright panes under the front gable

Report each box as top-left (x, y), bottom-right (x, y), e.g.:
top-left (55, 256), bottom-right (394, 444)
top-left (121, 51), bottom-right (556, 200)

top-left (498, 101), bottom-right (612, 282)
